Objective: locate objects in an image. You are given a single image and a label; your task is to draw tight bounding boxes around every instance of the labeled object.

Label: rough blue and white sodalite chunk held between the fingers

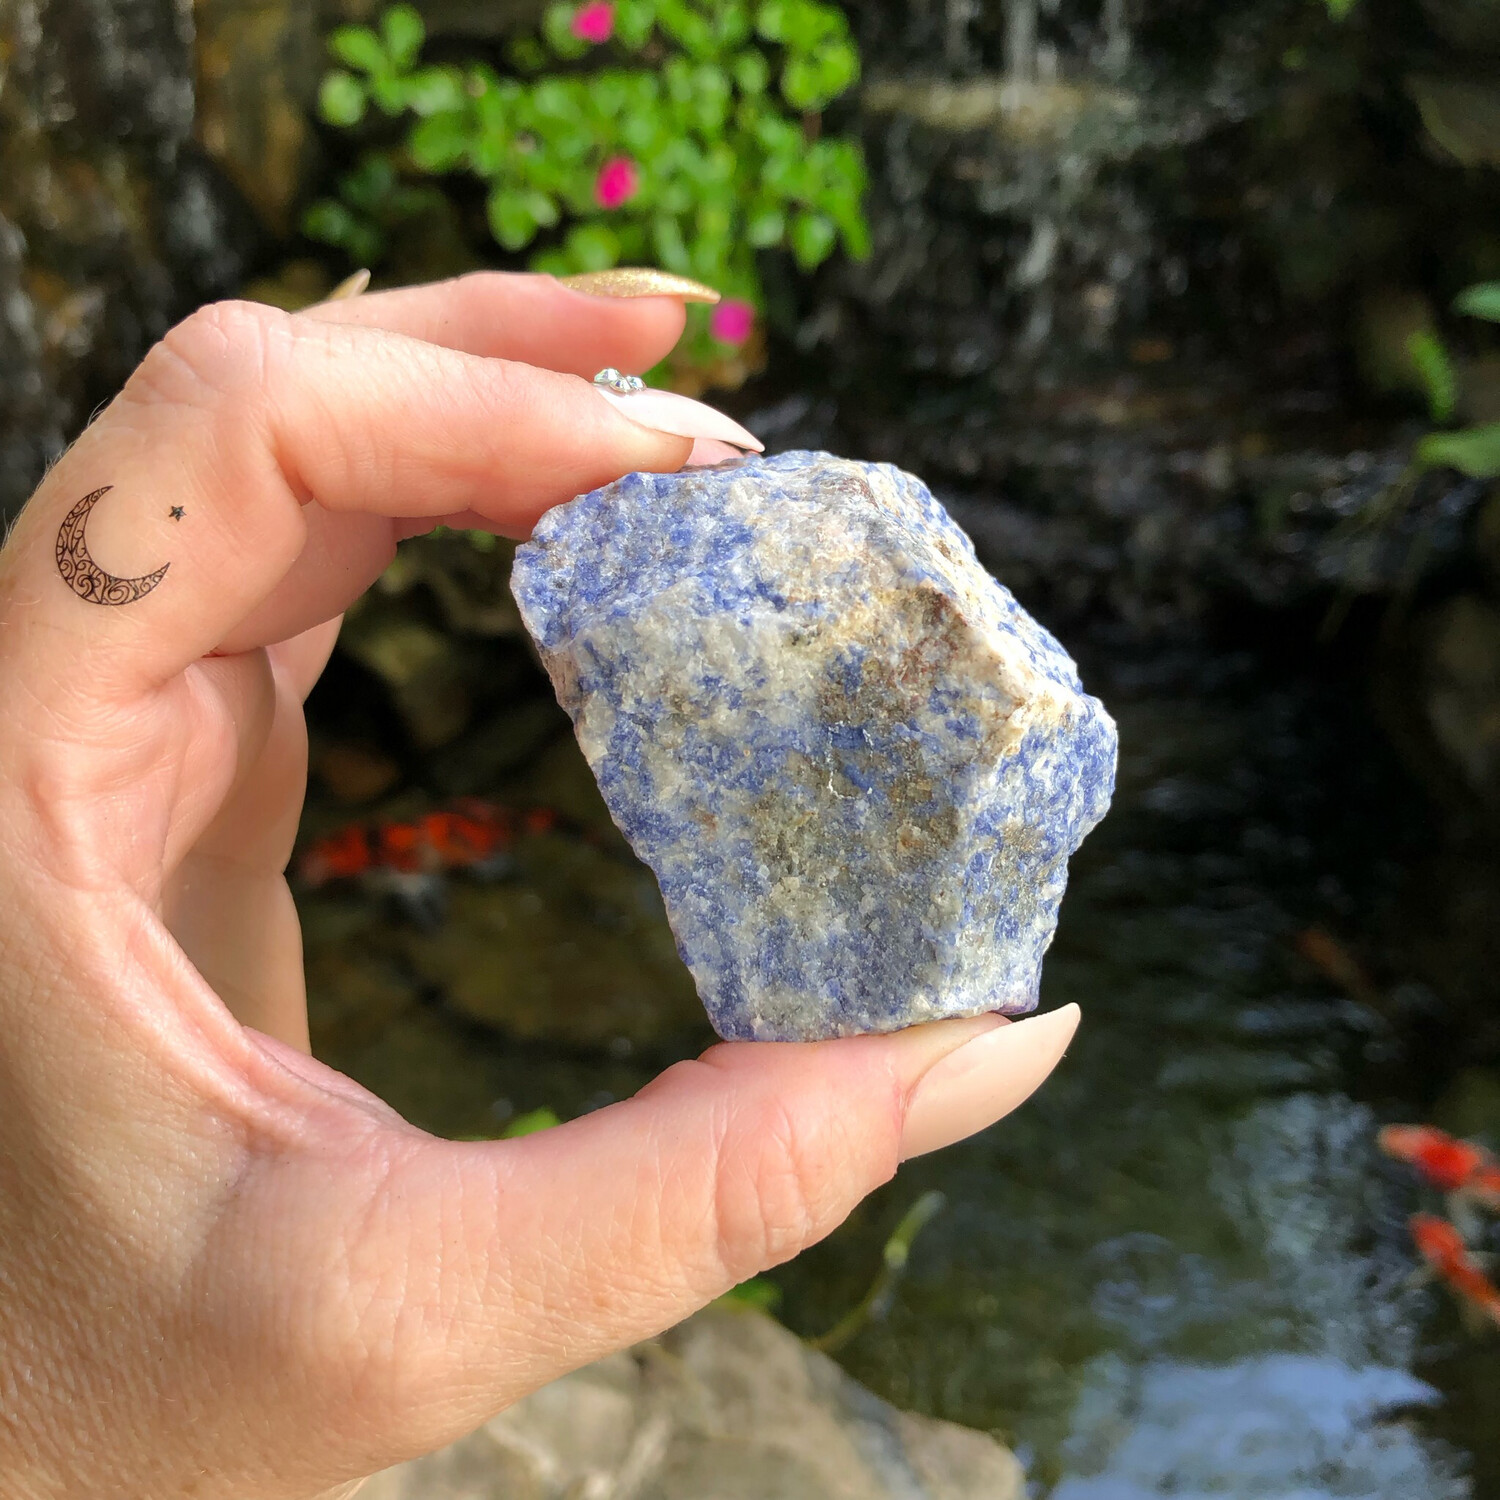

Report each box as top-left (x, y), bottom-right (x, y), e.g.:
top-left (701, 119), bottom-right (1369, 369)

top-left (512, 453), bottom-right (1115, 1041)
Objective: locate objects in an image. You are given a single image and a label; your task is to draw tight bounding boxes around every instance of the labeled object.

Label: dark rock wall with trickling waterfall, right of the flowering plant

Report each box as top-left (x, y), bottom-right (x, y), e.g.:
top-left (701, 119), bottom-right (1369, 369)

top-left (750, 0), bottom-right (1500, 633)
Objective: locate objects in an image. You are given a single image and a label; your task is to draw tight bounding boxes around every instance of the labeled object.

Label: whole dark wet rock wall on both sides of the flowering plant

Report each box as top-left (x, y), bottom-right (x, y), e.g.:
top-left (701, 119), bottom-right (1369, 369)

top-left (0, 0), bottom-right (1500, 822)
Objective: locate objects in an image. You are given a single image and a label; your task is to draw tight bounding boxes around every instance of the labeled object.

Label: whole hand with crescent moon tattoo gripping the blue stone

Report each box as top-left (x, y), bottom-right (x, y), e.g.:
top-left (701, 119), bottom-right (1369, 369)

top-left (0, 275), bottom-right (1077, 1500)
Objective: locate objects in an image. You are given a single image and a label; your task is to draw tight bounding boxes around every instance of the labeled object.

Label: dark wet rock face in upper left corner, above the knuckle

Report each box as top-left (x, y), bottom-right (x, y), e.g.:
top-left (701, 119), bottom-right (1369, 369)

top-left (0, 0), bottom-right (258, 516)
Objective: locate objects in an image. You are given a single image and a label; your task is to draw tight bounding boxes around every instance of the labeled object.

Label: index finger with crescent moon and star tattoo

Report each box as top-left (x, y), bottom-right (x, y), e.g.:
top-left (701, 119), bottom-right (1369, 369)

top-left (0, 303), bottom-right (692, 702)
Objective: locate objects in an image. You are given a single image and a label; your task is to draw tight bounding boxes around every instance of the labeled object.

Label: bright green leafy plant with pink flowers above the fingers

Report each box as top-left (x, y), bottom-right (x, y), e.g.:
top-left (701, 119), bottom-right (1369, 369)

top-left (303, 0), bottom-right (869, 372)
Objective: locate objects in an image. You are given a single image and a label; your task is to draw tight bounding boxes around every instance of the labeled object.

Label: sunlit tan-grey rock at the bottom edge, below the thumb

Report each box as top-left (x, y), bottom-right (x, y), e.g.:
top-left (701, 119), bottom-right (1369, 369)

top-left (360, 1308), bottom-right (1025, 1500)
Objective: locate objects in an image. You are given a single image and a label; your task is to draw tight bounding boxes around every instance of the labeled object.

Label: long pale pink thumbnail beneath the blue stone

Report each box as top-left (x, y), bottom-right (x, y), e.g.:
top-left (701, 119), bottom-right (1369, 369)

top-left (902, 1005), bottom-right (1079, 1161)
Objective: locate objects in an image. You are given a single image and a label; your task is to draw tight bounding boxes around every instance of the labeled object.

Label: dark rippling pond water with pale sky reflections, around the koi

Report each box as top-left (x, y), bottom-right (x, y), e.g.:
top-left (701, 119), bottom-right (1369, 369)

top-left (298, 615), bottom-right (1500, 1500)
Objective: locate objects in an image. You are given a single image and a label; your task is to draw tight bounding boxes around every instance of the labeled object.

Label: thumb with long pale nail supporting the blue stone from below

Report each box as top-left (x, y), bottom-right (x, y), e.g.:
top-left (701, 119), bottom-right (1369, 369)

top-left (237, 1007), bottom-right (1077, 1458)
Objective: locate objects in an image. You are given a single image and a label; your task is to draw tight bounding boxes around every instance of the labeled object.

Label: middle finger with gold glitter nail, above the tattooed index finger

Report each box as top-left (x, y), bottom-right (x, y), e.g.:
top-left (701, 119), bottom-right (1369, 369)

top-left (303, 272), bottom-right (687, 378)
